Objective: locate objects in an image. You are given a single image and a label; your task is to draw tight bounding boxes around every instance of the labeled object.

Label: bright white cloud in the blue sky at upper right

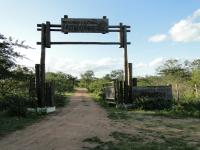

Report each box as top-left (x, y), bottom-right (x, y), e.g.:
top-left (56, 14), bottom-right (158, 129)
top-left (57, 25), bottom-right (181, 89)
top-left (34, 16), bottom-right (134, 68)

top-left (149, 9), bottom-right (200, 42)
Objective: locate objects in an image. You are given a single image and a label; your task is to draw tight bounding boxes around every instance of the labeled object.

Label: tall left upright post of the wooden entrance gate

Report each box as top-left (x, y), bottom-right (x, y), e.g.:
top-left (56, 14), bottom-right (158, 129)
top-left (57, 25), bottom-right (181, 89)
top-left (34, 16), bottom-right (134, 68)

top-left (40, 24), bottom-right (46, 107)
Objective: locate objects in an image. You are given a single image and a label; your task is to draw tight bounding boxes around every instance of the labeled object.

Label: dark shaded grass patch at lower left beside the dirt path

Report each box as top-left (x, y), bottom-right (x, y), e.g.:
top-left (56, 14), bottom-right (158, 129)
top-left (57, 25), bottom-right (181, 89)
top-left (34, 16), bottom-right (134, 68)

top-left (0, 112), bottom-right (45, 137)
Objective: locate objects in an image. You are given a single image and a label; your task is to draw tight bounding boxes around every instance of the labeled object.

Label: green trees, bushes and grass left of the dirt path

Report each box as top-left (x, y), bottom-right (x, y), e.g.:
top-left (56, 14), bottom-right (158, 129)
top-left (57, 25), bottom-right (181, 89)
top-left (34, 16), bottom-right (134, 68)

top-left (0, 34), bottom-right (76, 137)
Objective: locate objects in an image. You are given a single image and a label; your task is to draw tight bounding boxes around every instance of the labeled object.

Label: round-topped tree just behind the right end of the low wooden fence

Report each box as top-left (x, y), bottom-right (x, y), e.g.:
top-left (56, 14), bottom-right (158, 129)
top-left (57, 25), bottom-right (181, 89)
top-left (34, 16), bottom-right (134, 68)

top-left (157, 59), bottom-right (191, 101)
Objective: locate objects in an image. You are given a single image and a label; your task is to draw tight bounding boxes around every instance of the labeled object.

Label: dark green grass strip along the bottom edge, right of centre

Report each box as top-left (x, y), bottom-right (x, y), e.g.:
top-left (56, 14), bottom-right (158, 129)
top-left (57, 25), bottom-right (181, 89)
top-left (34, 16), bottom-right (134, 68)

top-left (83, 132), bottom-right (199, 150)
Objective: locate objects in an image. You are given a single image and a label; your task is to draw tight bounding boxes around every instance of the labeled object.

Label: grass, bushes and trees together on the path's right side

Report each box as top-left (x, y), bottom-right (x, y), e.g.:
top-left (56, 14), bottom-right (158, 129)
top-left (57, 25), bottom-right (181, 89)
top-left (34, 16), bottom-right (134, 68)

top-left (82, 59), bottom-right (200, 150)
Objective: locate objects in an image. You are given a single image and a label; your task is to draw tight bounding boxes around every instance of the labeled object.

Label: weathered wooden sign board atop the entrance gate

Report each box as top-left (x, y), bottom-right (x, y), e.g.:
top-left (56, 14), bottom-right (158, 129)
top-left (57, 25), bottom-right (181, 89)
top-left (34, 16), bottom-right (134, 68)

top-left (61, 18), bottom-right (108, 33)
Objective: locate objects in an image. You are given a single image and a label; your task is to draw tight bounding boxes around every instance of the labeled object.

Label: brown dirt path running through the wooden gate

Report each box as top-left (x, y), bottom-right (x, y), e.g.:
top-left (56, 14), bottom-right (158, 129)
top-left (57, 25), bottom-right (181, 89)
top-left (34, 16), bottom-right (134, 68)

top-left (0, 89), bottom-right (113, 150)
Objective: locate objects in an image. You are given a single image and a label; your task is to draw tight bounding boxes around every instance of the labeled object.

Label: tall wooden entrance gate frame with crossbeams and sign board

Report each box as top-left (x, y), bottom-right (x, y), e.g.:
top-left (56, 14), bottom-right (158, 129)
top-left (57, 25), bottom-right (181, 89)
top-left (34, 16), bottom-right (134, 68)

top-left (37, 15), bottom-right (130, 107)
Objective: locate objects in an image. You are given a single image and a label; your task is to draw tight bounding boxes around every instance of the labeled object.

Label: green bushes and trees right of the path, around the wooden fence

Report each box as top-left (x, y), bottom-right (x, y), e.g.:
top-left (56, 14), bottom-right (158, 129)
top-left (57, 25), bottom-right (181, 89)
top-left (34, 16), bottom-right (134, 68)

top-left (80, 59), bottom-right (200, 118)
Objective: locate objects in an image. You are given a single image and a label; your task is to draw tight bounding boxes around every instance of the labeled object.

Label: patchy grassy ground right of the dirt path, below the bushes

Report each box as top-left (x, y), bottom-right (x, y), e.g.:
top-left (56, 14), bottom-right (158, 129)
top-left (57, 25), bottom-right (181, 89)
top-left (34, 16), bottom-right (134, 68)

top-left (89, 95), bottom-right (200, 150)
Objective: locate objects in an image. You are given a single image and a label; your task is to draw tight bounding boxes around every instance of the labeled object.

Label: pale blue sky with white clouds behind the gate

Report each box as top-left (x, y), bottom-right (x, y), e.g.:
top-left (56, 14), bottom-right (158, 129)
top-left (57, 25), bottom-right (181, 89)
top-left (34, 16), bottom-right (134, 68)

top-left (0, 0), bottom-right (200, 77)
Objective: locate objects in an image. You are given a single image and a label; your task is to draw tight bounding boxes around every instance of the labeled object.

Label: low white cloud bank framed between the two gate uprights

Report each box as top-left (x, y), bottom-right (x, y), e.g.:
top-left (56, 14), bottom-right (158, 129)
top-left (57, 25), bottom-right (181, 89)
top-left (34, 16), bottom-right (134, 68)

top-left (46, 57), bottom-right (123, 76)
